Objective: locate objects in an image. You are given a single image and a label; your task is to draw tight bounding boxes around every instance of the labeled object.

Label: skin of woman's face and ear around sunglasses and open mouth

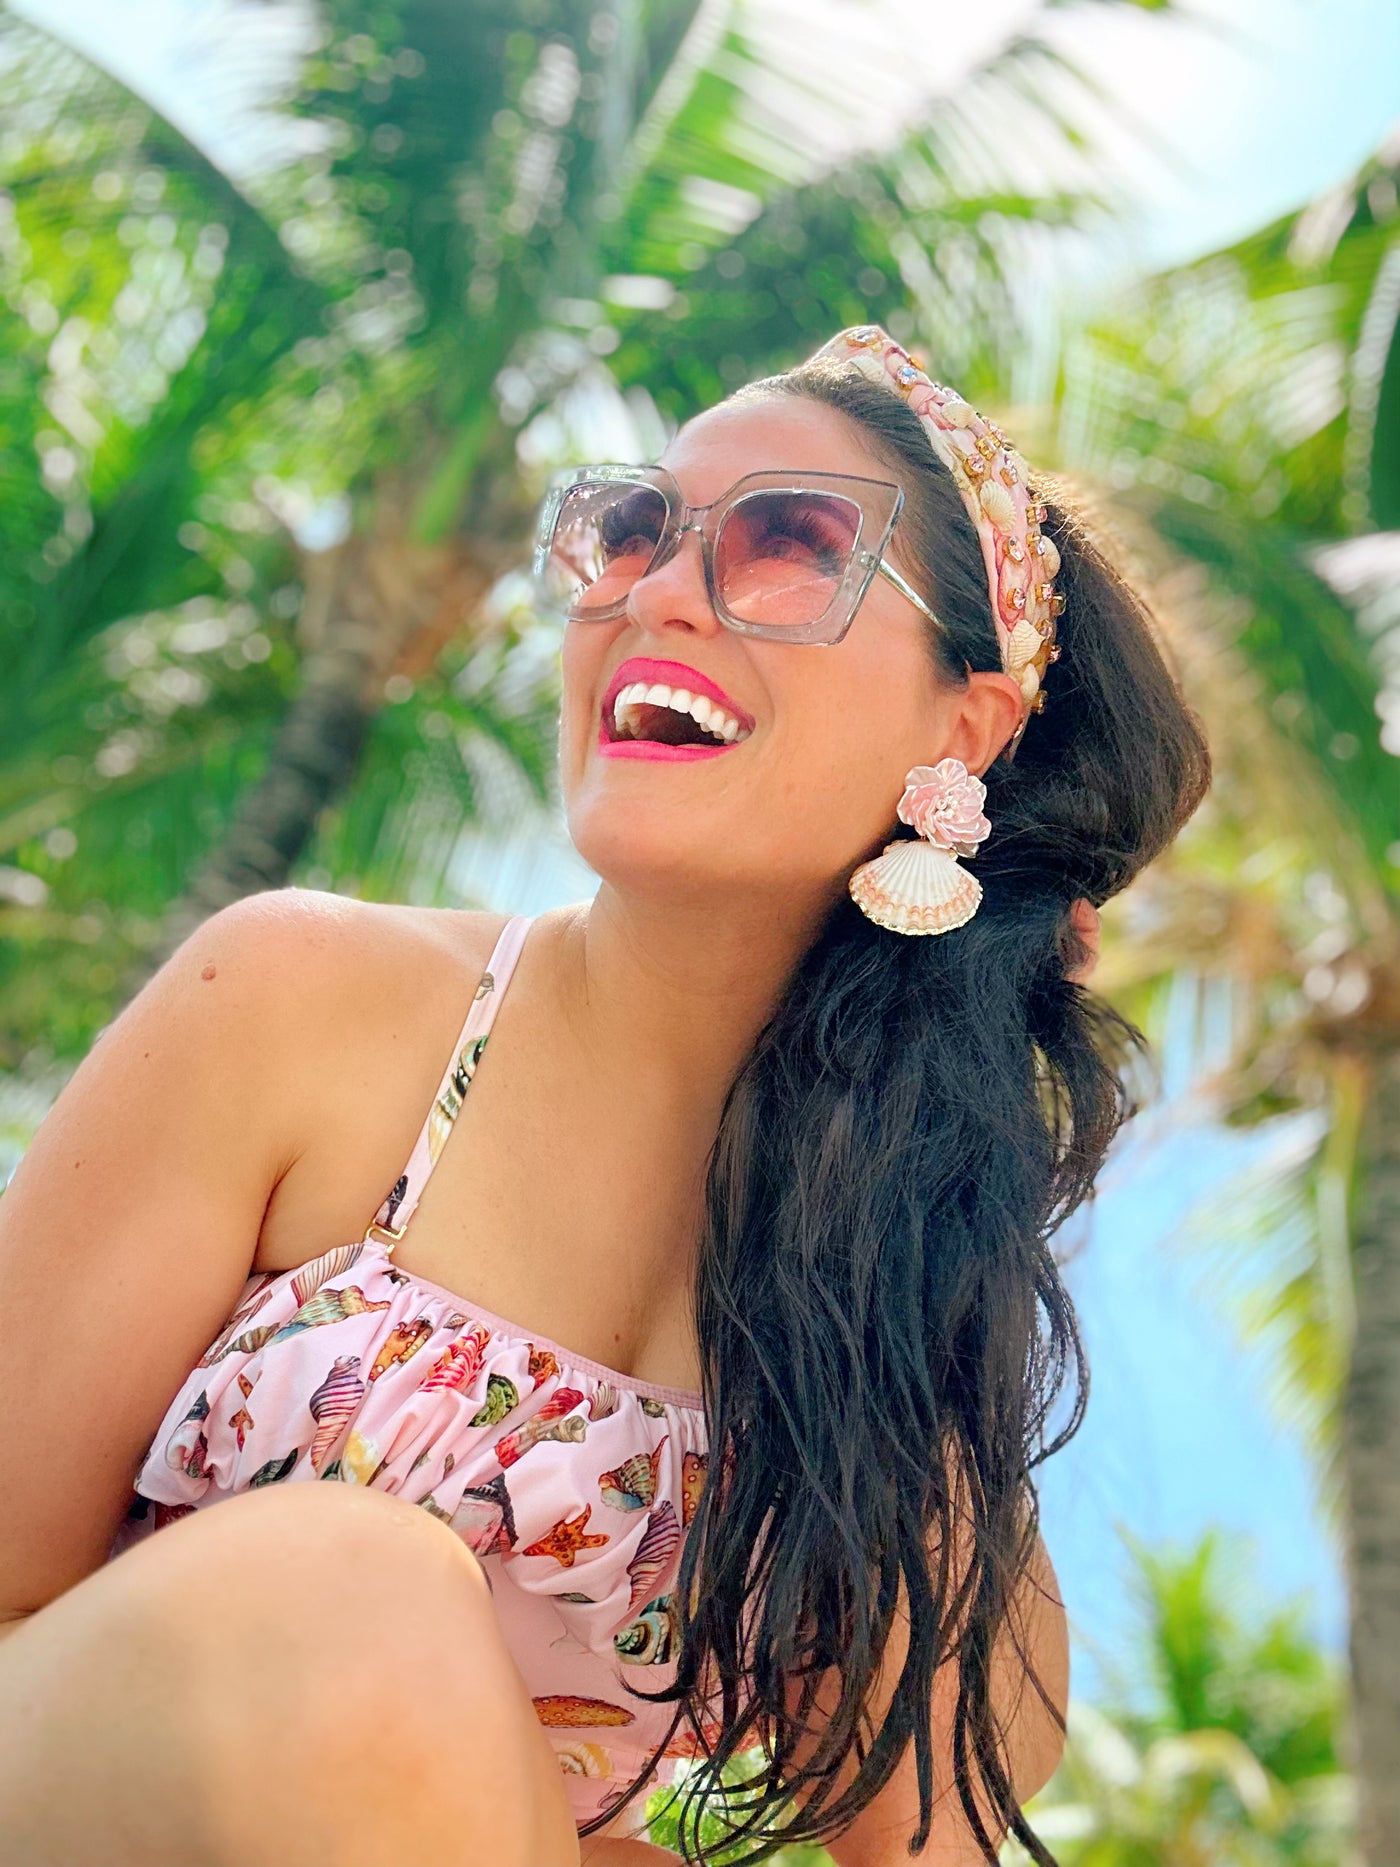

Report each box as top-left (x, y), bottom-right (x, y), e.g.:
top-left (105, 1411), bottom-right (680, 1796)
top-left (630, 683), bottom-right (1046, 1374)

top-left (560, 396), bottom-right (1019, 905)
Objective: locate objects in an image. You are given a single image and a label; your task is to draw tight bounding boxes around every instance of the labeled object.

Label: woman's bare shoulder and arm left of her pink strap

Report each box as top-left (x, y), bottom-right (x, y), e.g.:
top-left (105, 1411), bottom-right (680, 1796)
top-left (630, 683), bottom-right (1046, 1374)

top-left (0, 889), bottom-right (522, 1619)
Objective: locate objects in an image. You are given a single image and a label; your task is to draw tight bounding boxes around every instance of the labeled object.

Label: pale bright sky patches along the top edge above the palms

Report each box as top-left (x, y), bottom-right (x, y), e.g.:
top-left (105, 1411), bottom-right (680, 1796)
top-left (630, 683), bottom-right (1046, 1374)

top-left (21, 0), bottom-right (1400, 274)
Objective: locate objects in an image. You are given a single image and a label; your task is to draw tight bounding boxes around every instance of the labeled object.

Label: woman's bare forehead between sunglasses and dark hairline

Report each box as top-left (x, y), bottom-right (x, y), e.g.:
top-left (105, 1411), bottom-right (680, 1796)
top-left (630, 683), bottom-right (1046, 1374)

top-left (661, 396), bottom-right (894, 506)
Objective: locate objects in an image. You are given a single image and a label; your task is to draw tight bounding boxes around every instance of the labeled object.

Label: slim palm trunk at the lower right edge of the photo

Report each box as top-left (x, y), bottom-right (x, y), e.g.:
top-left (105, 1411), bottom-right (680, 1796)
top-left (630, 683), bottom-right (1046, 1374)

top-left (1342, 1047), bottom-right (1400, 1867)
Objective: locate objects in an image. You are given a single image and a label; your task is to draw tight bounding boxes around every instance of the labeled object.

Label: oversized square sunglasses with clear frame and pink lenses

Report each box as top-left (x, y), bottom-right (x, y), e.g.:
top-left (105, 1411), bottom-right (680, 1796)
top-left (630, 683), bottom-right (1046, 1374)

top-left (534, 467), bottom-right (943, 644)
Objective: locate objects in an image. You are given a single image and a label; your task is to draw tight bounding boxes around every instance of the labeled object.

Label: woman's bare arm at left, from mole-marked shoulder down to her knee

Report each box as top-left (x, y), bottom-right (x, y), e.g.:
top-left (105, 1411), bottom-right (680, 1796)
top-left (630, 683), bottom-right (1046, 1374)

top-left (0, 891), bottom-right (367, 1637)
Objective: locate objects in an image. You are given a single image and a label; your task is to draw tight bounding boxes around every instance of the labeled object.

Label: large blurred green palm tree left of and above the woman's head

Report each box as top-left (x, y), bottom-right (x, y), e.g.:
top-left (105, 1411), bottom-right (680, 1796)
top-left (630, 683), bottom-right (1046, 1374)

top-left (0, 0), bottom-right (1187, 1059)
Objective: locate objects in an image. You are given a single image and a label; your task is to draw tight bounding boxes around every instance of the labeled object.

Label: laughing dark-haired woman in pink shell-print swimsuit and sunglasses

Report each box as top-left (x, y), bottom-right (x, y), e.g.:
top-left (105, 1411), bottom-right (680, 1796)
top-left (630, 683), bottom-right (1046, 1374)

top-left (0, 327), bottom-right (1210, 1867)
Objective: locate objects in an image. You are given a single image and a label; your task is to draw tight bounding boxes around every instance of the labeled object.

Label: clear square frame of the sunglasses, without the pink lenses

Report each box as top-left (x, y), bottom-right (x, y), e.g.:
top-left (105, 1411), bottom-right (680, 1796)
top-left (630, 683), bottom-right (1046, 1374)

top-left (532, 467), bottom-right (941, 648)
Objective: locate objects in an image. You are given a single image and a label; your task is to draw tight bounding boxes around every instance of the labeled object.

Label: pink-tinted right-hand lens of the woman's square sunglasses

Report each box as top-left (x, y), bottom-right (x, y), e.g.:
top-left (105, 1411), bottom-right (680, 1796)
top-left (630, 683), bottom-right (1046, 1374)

top-left (715, 491), bottom-right (861, 627)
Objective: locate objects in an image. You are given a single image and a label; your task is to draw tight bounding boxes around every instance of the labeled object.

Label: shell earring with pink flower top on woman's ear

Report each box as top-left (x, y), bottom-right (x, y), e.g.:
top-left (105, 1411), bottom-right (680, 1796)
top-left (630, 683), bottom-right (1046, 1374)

top-left (849, 758), bottom-right (991, 934)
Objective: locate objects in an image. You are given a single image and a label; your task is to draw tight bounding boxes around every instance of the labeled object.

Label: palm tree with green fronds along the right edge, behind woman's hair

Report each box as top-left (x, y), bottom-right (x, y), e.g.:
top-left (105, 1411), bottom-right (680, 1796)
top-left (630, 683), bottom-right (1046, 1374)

top-left (1053, 135), bottom-right (1400, 1867)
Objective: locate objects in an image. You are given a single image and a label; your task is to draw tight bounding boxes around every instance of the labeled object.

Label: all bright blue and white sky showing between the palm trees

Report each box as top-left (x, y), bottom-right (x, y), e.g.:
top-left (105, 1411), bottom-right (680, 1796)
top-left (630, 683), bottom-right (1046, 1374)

top-left (15, 0), bottom-right (1400, 1682)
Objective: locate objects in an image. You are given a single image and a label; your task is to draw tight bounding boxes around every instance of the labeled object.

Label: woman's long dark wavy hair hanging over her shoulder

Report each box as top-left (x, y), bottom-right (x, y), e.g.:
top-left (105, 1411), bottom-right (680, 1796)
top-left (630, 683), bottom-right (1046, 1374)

top-left (582, 360), bottom-right (1210, 1867)
